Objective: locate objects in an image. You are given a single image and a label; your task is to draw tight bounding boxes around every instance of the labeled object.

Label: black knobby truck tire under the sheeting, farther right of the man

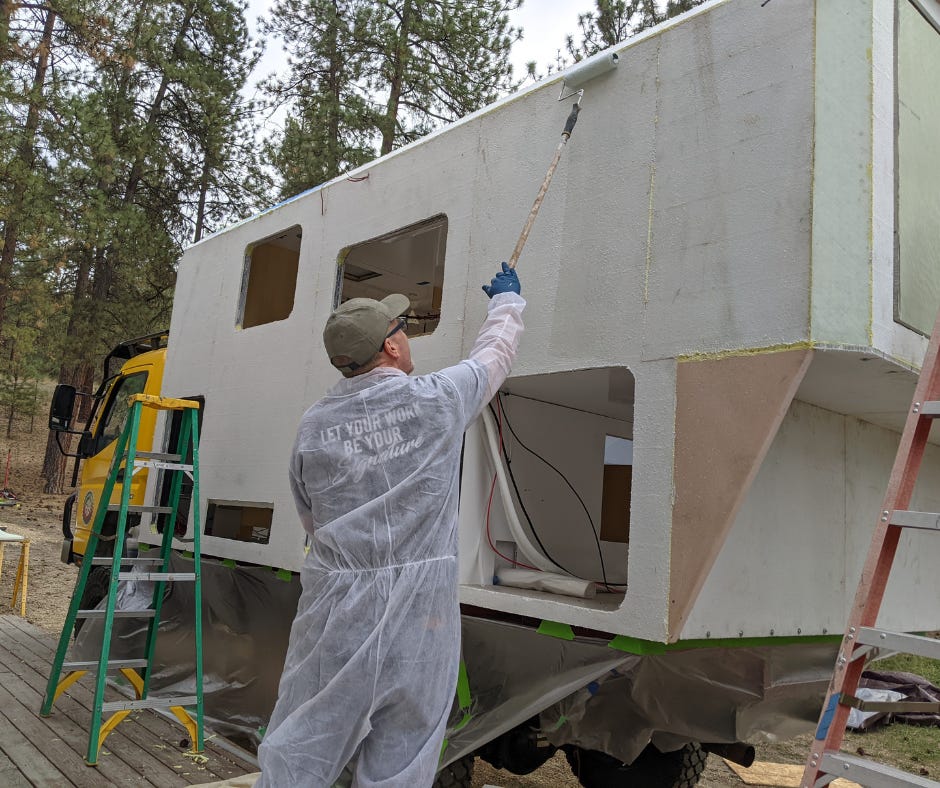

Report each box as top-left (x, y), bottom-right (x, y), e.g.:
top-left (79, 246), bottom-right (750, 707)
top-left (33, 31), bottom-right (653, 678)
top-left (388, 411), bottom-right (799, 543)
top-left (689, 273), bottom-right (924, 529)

top-left (565, 742), bottom-right (708, 788)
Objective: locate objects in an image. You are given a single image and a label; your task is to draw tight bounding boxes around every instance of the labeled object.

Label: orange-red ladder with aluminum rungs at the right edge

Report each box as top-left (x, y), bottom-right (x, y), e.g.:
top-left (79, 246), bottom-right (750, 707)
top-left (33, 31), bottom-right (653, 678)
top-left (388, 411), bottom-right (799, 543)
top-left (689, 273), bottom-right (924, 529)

top-left (800, 315), bottom-right (940, 788)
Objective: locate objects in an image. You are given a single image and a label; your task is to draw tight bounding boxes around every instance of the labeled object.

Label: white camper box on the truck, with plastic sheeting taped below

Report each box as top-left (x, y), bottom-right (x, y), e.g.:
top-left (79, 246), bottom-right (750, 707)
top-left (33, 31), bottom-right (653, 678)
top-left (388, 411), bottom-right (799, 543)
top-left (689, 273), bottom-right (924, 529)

top-left (114, 0), bottom-right (940, 776)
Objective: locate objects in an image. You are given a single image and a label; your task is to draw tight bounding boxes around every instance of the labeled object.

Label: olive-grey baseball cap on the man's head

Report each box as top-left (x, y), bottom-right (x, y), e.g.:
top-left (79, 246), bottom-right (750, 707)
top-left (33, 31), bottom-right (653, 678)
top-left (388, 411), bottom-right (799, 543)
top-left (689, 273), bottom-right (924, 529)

top-left (323, 293), bottom-right (411, 374)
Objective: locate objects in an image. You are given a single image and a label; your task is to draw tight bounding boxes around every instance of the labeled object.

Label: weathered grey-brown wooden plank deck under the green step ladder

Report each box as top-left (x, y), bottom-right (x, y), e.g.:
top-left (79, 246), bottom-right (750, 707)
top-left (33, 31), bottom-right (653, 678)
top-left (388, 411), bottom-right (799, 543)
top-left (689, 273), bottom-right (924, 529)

top-left (0, 614), bottom-right (257, 788)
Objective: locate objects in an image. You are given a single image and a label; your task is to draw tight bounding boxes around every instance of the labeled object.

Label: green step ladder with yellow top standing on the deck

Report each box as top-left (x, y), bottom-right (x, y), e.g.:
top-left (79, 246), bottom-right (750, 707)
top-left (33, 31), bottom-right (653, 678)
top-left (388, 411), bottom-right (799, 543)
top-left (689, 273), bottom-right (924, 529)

top-left (40, 394), bottom-right (204, 766)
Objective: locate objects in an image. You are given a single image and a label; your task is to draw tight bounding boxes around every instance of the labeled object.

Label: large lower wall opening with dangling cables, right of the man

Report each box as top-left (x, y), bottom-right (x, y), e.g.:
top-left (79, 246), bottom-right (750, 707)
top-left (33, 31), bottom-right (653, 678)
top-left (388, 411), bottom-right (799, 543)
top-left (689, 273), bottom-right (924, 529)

top-left (470, 367), bottom-right (634, 609)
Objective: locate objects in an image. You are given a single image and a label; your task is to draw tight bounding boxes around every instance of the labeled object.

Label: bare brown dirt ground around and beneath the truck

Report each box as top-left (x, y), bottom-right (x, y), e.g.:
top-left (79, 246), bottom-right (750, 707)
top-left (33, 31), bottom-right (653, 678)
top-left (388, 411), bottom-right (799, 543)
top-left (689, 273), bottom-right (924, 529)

top-left (0, 418), bottom-right (809, 788)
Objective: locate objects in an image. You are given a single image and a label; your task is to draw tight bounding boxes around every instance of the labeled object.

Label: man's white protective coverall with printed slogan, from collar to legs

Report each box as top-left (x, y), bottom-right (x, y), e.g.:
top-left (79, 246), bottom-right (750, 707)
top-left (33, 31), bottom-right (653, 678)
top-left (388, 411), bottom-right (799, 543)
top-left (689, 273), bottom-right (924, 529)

top-left (257, 293), bottom-right (525, 788)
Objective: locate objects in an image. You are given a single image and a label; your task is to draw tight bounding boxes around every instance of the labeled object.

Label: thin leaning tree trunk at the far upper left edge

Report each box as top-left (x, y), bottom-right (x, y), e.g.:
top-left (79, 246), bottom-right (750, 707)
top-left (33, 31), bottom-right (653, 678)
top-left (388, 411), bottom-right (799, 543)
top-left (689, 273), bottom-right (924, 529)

top-left (0, 6), bottom-right (56, 336)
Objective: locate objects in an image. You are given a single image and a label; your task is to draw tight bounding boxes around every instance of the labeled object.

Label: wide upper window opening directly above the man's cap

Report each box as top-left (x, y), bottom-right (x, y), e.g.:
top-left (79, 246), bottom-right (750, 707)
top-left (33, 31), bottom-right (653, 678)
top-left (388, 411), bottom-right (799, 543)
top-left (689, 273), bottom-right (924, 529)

top-left (335, 215), bottom-right (447, 337)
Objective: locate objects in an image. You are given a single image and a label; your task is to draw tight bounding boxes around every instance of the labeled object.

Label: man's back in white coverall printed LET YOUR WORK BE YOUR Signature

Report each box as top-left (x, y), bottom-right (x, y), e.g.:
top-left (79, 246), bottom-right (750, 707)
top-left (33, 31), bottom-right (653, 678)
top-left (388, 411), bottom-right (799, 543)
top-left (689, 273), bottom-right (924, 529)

top-left (291, 362), bottom-right (486, 569)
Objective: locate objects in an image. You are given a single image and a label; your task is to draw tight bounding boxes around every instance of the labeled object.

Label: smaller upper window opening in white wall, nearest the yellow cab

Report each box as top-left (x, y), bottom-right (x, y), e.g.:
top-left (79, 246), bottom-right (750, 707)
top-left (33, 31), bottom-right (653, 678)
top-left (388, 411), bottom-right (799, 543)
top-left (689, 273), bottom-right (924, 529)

top-left (238, 225), bottom-right (301, 328)
